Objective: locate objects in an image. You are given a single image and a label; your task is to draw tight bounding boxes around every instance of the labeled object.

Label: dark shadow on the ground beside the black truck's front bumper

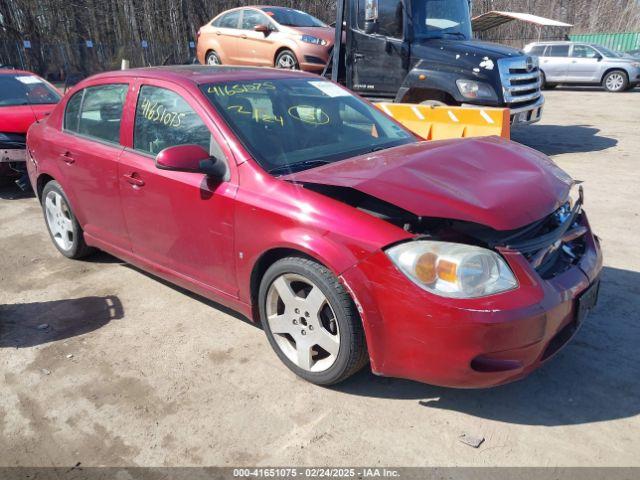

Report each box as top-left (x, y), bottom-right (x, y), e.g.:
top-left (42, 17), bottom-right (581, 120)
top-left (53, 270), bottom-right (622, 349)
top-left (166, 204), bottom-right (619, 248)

top-left (511, 124), bottom-right (618, 155)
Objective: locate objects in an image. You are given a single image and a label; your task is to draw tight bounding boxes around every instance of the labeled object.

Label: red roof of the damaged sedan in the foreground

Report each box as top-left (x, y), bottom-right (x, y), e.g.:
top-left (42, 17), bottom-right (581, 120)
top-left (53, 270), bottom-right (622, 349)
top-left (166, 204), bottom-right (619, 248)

top-left (82, 65), bottom-right (317, 85)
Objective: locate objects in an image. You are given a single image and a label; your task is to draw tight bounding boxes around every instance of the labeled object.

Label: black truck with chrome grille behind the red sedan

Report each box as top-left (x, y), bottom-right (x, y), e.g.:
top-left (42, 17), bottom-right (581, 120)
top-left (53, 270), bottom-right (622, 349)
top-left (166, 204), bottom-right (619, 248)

top-left (331, 0), bottom-right (544, 124)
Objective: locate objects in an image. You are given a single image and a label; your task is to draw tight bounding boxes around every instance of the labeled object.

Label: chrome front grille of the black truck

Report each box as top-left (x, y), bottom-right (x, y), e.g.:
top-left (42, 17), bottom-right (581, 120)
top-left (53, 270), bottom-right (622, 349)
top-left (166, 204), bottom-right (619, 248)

top-left (498, 57), bottom-right (542, 108)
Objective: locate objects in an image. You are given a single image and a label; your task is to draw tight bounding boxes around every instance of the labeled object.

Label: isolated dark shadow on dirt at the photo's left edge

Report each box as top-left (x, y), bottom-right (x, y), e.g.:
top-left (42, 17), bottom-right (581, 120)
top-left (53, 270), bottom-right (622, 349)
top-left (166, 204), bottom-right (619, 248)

top-left (0, 295), bottom-right (124, 348)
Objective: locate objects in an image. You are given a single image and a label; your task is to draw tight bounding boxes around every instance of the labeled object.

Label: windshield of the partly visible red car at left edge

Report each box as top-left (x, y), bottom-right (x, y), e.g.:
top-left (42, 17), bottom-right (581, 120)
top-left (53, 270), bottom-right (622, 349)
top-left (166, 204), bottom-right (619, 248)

top-left (0, 74), bottom-right (60, 107)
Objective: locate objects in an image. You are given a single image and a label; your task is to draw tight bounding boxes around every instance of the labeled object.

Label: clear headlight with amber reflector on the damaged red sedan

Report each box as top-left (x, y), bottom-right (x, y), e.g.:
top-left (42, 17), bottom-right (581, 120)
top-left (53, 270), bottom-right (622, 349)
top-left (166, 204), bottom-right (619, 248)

top-left (386, 240), bottom-right (518, 298)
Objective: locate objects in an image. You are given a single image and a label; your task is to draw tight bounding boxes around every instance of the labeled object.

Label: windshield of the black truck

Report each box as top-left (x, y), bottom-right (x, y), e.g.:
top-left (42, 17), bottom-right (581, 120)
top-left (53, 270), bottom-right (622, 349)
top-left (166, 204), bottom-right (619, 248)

top-left (412, 0), bottom-right (471, 40)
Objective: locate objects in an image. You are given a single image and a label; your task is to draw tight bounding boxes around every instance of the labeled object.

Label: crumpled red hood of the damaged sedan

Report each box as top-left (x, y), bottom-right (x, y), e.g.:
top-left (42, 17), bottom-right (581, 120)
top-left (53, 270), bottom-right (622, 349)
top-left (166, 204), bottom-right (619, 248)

top-left (282, 137), bottom-right (572, 230)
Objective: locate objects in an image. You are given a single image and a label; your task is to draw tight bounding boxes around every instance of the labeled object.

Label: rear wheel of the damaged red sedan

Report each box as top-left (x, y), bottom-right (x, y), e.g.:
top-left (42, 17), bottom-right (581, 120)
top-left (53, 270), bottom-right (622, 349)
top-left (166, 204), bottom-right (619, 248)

top-left (42, 180), bottom-right (93, 259)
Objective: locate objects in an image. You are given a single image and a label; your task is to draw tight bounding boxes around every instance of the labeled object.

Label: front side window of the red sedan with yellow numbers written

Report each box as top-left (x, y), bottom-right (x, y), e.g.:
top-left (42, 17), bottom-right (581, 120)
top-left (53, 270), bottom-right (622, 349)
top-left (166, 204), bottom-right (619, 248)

top-left (133, 85), bottom-right (220, 155)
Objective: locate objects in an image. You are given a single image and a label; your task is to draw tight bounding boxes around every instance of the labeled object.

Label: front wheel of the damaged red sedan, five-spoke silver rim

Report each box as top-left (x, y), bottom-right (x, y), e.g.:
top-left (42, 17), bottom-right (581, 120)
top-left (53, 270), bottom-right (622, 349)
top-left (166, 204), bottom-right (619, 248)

top-left (259, 257), bottom-right (368, 385)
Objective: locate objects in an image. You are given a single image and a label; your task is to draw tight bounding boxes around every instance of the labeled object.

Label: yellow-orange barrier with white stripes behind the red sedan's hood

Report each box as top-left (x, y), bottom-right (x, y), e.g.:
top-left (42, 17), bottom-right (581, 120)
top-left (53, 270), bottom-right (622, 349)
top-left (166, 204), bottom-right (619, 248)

top-left (376, 102), bottom-right (511, 140)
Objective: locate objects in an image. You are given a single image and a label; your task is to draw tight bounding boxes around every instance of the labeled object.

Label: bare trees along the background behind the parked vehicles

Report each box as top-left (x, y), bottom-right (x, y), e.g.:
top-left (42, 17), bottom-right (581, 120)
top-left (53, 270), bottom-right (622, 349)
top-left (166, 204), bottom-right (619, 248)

top-left (0, 0), bottom-right (640, 77)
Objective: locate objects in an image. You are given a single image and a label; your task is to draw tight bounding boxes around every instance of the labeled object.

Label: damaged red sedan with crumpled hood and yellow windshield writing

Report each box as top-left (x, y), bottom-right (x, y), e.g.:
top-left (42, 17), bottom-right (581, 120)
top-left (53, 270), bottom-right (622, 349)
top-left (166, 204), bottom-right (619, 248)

top-left (27, 66), bottom-right (602, 387)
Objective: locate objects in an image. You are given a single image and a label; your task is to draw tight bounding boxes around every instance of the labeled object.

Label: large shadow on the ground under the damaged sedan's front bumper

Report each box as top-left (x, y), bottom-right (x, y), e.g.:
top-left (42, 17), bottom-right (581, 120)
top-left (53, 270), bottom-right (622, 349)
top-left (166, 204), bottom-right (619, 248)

top-left (333, 268), bottom-right (640, 426)
